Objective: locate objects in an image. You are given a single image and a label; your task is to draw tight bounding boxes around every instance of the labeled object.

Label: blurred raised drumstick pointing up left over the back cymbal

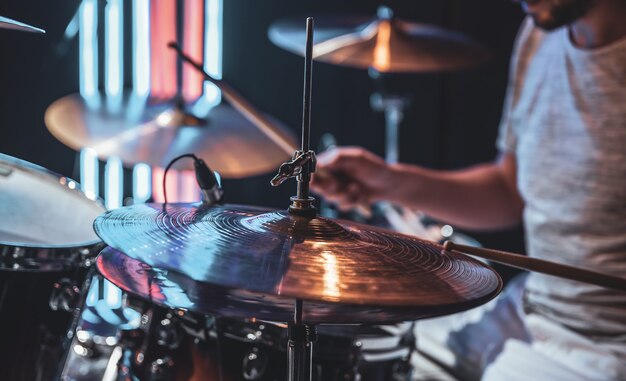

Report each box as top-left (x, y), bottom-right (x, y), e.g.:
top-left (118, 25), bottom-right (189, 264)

top-left (168, 42), bottom-right (297, 156)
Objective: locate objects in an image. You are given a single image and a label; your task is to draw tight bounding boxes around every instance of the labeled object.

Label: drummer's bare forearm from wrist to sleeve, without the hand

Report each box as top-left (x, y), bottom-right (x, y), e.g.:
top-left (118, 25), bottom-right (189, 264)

top-left (385, 153), bottom-right (524, 229)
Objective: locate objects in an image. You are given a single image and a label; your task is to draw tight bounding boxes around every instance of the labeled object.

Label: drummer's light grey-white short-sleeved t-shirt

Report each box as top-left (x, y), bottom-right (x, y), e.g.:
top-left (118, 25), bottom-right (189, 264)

top-left (497, 19), bottom-right (626, 357)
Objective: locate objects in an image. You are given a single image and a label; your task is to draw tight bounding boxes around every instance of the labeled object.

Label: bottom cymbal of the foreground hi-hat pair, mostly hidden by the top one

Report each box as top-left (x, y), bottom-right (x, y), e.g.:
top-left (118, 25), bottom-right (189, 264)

top-left (96, 247), bottom-right (500, 324)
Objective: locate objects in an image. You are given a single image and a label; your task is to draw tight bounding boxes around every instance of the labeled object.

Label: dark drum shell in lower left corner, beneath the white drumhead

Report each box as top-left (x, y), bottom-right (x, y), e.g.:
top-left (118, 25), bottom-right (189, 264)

top-left (0, 267), bottom-right (89, 381)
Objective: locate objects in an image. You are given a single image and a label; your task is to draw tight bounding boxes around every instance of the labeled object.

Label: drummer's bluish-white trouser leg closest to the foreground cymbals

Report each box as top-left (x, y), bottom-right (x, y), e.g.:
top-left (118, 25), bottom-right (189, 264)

top-left (412, 277), bottom-right (530, 380)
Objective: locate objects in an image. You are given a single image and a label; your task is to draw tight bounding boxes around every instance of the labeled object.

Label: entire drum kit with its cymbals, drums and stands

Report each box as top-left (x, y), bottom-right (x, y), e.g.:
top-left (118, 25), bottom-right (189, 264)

top-left (0, 8), bottom-right (625, 381)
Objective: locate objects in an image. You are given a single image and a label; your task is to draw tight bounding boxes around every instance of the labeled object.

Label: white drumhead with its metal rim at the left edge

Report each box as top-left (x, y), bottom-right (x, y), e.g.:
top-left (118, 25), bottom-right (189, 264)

top-left (0, 154), bottom-right (105, 271)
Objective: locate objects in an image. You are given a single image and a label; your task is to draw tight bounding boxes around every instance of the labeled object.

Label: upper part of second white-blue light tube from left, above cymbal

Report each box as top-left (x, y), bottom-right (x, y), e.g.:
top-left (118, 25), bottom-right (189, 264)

top-left (104, 0), bottom-right (124, 98)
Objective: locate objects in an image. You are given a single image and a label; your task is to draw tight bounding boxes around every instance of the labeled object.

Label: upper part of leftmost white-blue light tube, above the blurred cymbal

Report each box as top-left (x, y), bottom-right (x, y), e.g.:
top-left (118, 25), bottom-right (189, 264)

top-left (78, 0), bottom-right (98, 101)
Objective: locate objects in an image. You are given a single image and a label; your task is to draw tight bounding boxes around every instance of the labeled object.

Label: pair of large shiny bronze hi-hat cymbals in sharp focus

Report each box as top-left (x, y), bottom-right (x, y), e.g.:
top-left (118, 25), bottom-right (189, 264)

top-left (94, 204), bottom-right (502, 323)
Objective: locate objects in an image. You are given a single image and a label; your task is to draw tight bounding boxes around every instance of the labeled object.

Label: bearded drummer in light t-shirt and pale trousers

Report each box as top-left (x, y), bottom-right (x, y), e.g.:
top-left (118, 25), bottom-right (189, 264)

top-left (313, 0), bottom-right (626, 380)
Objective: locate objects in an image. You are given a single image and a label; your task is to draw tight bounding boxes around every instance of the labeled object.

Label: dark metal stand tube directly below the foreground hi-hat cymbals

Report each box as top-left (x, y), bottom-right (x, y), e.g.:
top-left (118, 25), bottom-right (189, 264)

top-left (287, 299), bottom-right (317, 381)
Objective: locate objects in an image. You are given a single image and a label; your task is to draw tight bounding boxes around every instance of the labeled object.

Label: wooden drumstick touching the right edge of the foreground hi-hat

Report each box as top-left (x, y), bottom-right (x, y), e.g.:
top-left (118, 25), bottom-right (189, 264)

top-left (443, 241), bottom-right (626, 291)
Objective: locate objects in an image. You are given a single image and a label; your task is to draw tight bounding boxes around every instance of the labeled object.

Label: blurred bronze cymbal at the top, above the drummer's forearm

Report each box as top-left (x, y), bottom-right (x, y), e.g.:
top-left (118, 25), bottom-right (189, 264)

top-left (268, 7), bottom-right (490, 73)
